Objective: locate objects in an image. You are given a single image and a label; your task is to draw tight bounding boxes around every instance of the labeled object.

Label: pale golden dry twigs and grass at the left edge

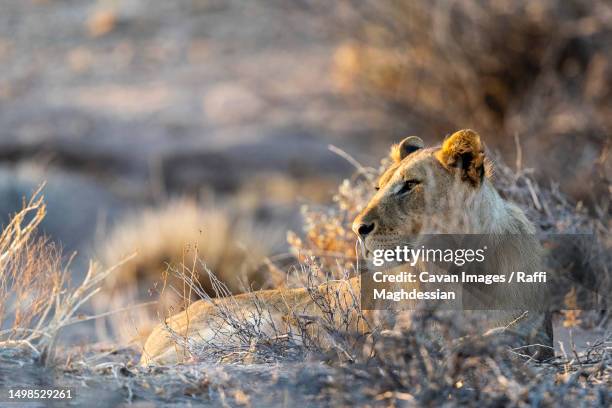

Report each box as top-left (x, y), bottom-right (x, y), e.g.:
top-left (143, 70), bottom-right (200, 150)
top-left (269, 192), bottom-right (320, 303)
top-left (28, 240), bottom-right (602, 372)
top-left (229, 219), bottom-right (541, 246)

top-left (0, 186), bottom-right (128, 362)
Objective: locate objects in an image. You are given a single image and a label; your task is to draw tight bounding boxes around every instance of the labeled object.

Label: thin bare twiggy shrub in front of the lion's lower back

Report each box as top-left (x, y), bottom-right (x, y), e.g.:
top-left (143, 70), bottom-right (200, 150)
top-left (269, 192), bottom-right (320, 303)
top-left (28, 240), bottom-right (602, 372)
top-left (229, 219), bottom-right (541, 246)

top-left (166, 253), bottom-right (371, 363)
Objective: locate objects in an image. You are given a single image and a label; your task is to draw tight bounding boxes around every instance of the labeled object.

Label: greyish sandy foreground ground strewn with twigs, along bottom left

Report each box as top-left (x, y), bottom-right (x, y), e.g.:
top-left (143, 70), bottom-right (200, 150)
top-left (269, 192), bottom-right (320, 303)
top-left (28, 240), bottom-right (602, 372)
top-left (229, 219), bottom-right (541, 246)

top-left (0, 327), bottom-right (604, 407)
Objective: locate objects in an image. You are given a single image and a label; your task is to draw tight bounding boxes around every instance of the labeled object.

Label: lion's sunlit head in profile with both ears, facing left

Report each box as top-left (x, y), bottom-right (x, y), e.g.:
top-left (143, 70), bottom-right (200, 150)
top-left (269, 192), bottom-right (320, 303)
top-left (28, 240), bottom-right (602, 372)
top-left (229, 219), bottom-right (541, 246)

top-left (353, 130), bottom-right (495, 252)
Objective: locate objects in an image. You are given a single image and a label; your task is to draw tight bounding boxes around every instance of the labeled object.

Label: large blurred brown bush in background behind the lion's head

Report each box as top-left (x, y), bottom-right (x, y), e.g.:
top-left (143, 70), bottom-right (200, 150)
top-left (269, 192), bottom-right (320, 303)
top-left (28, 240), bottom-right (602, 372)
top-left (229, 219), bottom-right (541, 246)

top-left (334, 0), bottom-right (612, 204)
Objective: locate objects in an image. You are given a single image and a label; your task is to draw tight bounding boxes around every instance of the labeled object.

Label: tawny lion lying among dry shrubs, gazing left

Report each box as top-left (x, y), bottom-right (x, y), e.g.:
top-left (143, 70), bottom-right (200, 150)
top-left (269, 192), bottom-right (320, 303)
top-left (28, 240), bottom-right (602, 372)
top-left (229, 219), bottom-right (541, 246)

top-left (141, 130), bottom-right (552, 365)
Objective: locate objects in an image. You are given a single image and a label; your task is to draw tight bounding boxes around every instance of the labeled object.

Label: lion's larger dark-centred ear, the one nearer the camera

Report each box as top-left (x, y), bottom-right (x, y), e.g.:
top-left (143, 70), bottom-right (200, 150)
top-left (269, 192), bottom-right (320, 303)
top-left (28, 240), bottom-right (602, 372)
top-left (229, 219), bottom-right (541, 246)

top-left (436, 129), bottom-right (485, 185)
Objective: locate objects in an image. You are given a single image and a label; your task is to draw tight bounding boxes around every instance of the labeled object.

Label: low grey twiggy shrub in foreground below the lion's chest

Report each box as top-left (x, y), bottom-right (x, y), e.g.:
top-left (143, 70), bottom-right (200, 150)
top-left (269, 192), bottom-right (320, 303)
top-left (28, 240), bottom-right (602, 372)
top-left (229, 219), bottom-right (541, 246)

top-left (338, 320), bottom-right (612, 407)
